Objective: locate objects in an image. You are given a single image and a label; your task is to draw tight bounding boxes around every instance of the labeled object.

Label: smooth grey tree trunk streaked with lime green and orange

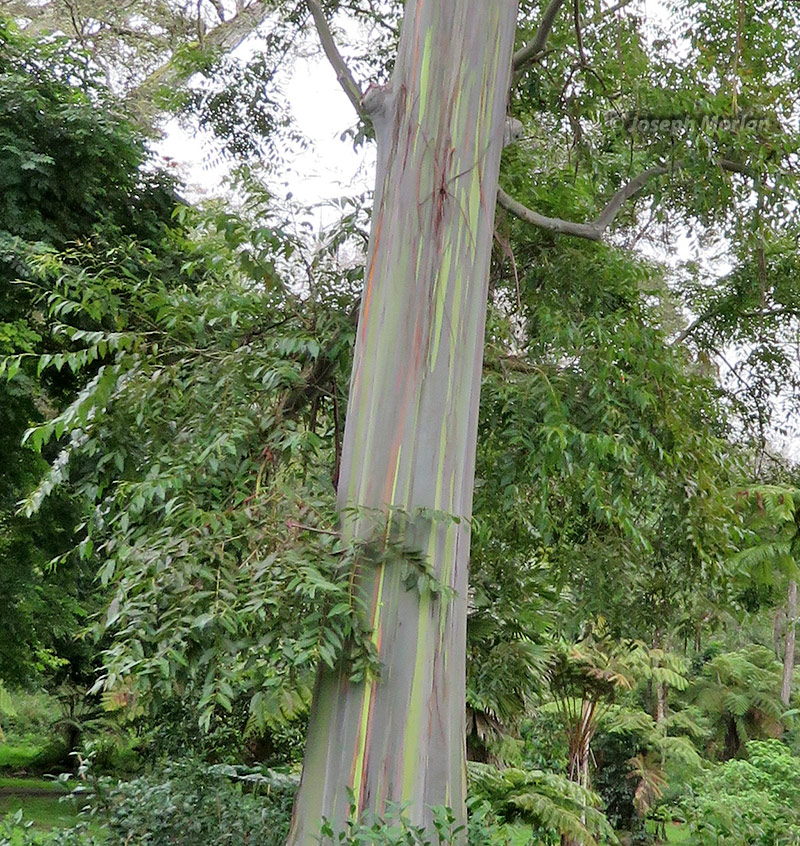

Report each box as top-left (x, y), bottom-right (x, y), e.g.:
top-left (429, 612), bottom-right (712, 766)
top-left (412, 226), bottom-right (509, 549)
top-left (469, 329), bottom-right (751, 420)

top-left (289, 0), bottom-right (517, 846)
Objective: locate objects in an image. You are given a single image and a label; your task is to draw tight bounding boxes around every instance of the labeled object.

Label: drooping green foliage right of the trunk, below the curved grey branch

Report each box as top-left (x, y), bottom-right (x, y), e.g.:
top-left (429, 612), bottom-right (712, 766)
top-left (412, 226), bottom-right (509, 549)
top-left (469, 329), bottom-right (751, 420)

top-left (474, 234), bottom-right (740, 642)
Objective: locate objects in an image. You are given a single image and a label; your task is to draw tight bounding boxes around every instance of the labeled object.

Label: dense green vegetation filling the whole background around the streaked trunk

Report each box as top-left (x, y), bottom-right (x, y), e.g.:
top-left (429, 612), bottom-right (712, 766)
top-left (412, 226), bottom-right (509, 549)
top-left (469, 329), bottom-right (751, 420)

top-left (0, 0), bottom-right (800, 846)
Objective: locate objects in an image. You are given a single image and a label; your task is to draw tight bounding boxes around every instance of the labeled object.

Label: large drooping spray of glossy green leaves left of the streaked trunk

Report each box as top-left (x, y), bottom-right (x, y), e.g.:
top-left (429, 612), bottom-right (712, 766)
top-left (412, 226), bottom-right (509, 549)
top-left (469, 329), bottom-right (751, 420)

top-left (10, 202), bottom-right (372, 726)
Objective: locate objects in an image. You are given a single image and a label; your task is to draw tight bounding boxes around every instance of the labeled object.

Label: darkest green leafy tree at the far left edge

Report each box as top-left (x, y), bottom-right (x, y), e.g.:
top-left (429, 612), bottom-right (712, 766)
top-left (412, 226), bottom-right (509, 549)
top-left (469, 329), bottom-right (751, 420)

top-left (0, 15), bottom-right (180, 684)
